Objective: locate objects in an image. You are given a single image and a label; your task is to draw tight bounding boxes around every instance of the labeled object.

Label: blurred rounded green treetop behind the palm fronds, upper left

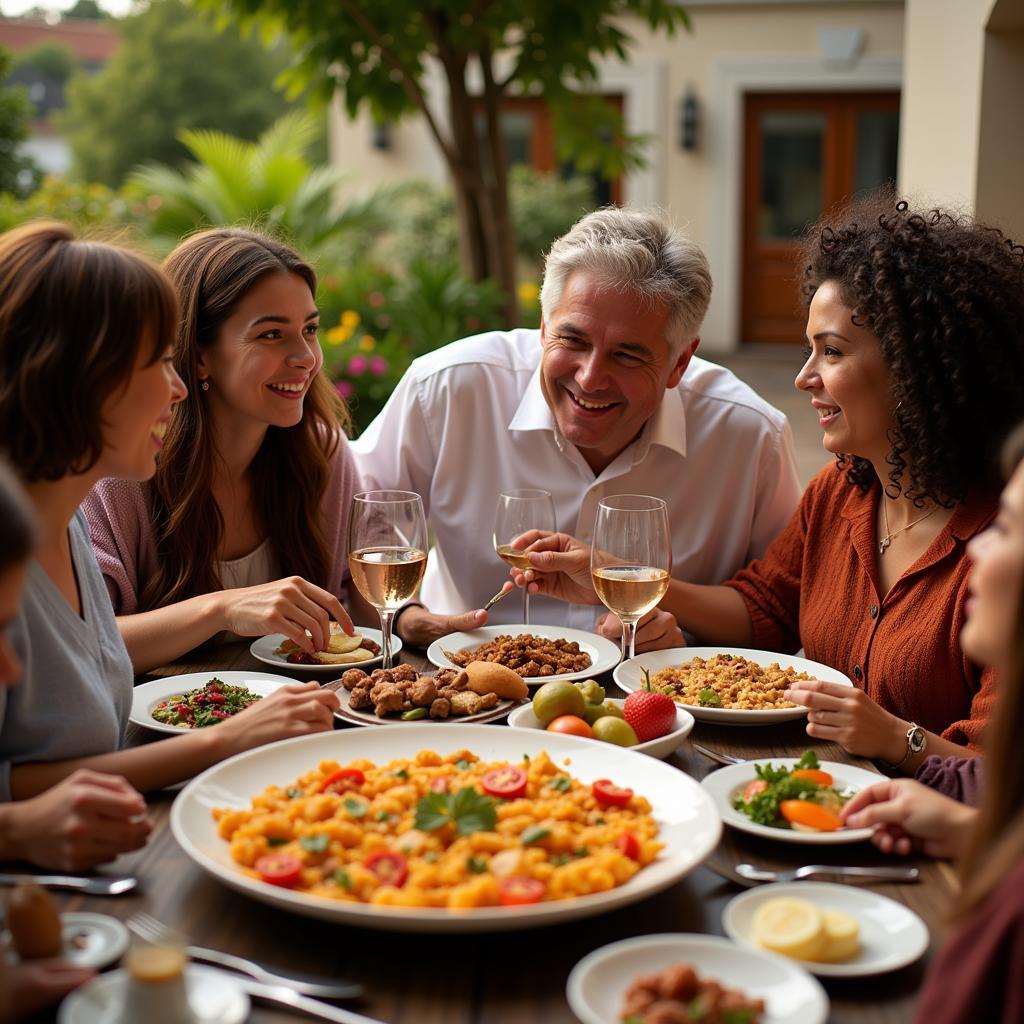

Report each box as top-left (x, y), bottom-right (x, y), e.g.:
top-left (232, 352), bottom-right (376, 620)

top-left (60, 0), bottom-right (289, 186)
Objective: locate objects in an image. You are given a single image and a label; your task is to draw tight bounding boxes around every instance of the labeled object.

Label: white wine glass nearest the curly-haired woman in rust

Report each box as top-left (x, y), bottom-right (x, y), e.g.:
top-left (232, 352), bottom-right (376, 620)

top-left (590, 495), bottom-right (672, 660)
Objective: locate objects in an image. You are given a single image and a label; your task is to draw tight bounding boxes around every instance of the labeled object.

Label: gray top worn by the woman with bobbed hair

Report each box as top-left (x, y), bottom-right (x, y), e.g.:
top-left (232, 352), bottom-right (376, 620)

top-left (0, 512), bottom-right (134, 800)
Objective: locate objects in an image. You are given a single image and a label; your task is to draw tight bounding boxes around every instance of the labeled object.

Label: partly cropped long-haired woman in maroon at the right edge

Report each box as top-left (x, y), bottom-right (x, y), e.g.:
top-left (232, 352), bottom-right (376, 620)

top-left (844, 428), bottom-right (1024, 1024)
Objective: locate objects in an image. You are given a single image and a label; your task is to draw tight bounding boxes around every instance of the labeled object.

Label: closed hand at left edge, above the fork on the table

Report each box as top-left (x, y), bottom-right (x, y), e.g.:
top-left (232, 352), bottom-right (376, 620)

top-left (3, 768), bottom-right (153, 871)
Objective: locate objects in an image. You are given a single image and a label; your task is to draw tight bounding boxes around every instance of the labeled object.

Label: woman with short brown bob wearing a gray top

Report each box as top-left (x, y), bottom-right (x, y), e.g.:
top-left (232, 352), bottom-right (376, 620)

top-left (0, 223), bottom-right (337, 798)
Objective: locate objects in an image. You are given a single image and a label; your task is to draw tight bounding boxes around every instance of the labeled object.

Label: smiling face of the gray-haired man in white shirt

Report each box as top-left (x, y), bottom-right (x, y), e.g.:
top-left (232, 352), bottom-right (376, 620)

top-left (541, 270), bottom-right (697, 473)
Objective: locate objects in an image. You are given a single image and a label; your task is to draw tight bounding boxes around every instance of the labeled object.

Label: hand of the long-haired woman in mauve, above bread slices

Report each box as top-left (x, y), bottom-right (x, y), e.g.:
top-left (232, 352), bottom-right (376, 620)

top-left (210, 577), bottom-right (355, 654)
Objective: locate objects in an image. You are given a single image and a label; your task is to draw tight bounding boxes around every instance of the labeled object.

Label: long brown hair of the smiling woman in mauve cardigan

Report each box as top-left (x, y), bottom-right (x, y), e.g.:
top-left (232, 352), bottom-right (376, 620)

top-left (140, 228), bottom-right (348, 610)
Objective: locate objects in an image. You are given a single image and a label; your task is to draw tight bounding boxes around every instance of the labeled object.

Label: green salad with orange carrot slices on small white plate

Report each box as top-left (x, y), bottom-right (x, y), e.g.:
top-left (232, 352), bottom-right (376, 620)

top-left (732, 751), bottom-right (853, 831)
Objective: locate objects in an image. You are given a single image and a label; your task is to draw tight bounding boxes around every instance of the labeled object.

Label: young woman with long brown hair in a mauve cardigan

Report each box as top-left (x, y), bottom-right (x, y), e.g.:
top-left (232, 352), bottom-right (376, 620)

top-left (84, 228), bottom-right (362, 671)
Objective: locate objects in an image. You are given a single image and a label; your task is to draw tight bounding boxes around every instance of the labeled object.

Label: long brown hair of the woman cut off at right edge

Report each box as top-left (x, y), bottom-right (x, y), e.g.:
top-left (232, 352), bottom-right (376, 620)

top-left (954, 425), bottom-right (1024, 916)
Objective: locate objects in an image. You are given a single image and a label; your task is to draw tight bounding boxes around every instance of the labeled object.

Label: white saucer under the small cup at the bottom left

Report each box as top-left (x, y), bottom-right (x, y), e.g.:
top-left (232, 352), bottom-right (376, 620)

top-left (57, 964), bottom-right (250, 1024)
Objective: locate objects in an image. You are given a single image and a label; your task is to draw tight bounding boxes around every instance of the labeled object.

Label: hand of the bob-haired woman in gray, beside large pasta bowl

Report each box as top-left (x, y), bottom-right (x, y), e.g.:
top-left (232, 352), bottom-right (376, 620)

top-left (210, 683), bottom-right (341, 757)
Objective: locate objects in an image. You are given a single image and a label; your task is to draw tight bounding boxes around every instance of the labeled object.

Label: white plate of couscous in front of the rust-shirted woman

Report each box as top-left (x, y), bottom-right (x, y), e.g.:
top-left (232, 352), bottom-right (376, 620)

top-left (613, 647), bottom-right (853, 725)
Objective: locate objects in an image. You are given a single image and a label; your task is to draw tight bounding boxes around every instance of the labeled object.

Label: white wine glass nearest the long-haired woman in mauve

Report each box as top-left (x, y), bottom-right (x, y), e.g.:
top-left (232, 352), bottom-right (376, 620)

top-left (348, 490), bottom-right (427, 669)
